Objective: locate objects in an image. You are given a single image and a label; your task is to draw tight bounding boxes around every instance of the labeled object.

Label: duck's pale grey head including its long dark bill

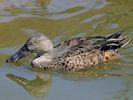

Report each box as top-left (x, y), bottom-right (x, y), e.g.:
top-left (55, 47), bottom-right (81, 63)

top-left (6, 35), bottom-right (53, 62)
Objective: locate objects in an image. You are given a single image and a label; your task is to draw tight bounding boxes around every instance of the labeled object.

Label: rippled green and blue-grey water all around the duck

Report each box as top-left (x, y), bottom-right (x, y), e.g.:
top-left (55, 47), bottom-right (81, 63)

top-left (0, 0), bottom-right (133, 100)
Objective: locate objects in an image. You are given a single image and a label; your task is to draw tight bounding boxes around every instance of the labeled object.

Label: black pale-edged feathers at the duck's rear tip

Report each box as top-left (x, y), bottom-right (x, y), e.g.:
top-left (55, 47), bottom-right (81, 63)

top-left (100, 32), bottom-right (130, 51)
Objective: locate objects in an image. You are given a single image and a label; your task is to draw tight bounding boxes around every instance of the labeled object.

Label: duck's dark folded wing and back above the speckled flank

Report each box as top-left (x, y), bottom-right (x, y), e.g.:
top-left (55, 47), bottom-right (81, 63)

top-left (61, 32), bottom-right (129, 56)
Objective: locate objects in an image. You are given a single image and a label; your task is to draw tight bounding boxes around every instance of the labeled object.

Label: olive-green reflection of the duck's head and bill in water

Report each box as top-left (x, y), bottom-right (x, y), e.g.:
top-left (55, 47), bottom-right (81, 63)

top-left (6, 73), bottom-right (51, 97)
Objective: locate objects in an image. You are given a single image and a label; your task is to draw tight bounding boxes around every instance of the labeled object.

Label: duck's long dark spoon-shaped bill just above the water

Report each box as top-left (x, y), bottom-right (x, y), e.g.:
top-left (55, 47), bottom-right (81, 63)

top-left (6, 44), bottom-right (31, 63)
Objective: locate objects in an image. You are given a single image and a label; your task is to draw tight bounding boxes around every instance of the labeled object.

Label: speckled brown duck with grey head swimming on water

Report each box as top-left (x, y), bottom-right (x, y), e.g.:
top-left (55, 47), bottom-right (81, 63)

top-left (6, 32), bottom-right (130, 71)
